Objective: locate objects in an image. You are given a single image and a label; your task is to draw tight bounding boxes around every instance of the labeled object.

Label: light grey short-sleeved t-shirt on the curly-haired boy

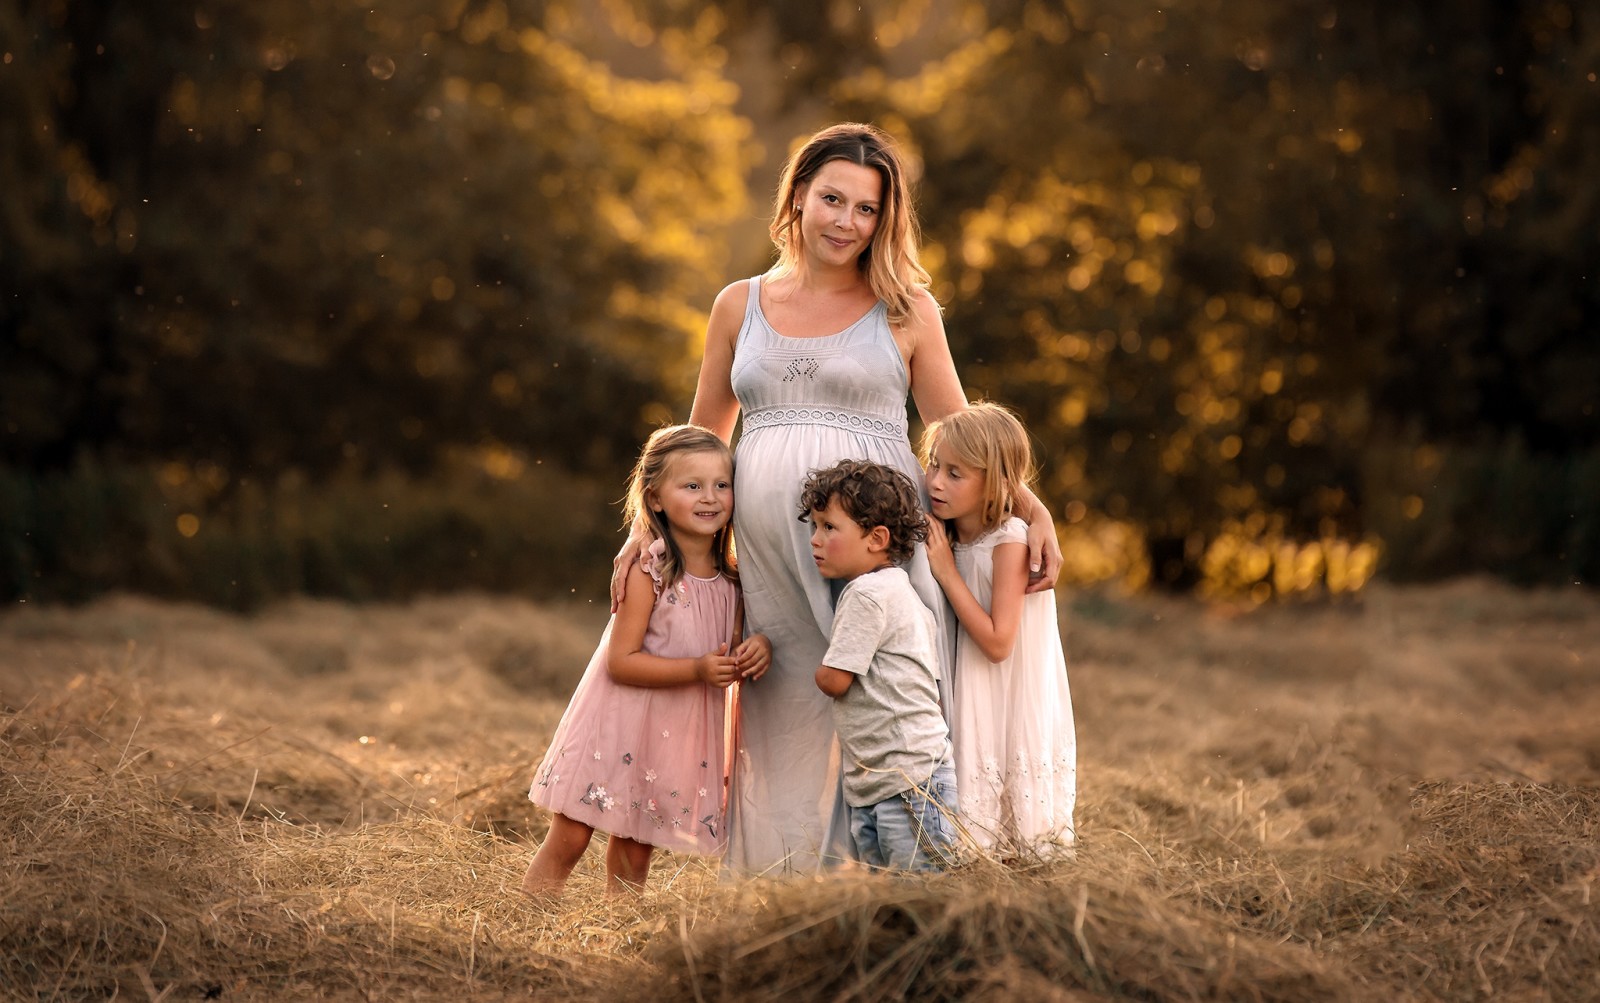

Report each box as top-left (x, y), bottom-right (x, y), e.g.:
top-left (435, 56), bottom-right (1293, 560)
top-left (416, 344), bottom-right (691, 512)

top-left (822, 568), bottom-right (950, 808)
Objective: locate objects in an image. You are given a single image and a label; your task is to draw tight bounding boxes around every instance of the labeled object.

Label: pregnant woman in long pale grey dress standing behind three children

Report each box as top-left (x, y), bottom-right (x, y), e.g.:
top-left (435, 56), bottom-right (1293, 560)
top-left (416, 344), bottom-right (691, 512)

top-left (618, 123), bottom-right (1061, 875)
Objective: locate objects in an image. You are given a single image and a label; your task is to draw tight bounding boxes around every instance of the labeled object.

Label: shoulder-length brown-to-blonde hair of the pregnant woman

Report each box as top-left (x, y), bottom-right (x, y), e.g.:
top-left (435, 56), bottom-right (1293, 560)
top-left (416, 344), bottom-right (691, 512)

top-left (768, 122), bottom-right (931, 326)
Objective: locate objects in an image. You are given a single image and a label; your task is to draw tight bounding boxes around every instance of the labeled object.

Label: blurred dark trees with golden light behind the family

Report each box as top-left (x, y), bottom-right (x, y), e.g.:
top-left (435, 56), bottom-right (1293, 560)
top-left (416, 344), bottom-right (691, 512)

top-left (0, 0), bottom-right (1600, 605)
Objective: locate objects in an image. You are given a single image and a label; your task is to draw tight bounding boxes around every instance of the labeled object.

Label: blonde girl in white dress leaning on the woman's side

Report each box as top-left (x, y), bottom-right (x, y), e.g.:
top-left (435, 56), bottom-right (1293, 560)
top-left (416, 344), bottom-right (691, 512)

top-left (922, 402), bottom-right (1078, 861)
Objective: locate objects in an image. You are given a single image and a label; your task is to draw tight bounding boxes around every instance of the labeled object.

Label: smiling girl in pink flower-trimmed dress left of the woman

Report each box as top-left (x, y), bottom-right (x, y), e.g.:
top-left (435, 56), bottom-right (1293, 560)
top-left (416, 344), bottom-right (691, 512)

top-left (522, 426), bottom-right (771, 896)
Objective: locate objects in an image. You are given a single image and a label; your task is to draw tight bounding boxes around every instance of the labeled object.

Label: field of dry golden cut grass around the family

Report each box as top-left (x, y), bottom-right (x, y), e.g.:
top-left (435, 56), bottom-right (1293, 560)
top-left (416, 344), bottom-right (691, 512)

top-left (0, 581), bottom-right (1600, 1000)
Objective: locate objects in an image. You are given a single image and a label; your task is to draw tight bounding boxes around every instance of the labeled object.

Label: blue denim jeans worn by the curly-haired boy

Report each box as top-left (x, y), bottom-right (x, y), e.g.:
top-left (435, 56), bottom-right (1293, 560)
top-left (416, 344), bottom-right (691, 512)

top-left (850, 761), bottom-right (957, 870)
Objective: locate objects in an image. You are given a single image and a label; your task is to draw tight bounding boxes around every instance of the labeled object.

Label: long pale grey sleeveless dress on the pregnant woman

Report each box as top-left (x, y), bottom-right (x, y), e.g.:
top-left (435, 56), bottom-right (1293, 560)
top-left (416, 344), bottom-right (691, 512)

top-left (725, 277), bottom-right (954, 875)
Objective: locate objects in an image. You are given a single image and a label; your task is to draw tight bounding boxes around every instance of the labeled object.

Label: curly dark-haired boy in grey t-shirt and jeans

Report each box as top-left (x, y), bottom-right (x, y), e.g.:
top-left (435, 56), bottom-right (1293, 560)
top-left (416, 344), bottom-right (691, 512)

top-left (800, 461), bottom-right (957, 870)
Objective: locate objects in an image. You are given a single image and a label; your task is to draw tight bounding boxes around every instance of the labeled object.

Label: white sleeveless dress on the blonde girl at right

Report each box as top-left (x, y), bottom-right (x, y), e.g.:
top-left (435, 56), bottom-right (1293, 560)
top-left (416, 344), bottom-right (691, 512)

top-left (950, 517), bottom-right (1078, 857)
